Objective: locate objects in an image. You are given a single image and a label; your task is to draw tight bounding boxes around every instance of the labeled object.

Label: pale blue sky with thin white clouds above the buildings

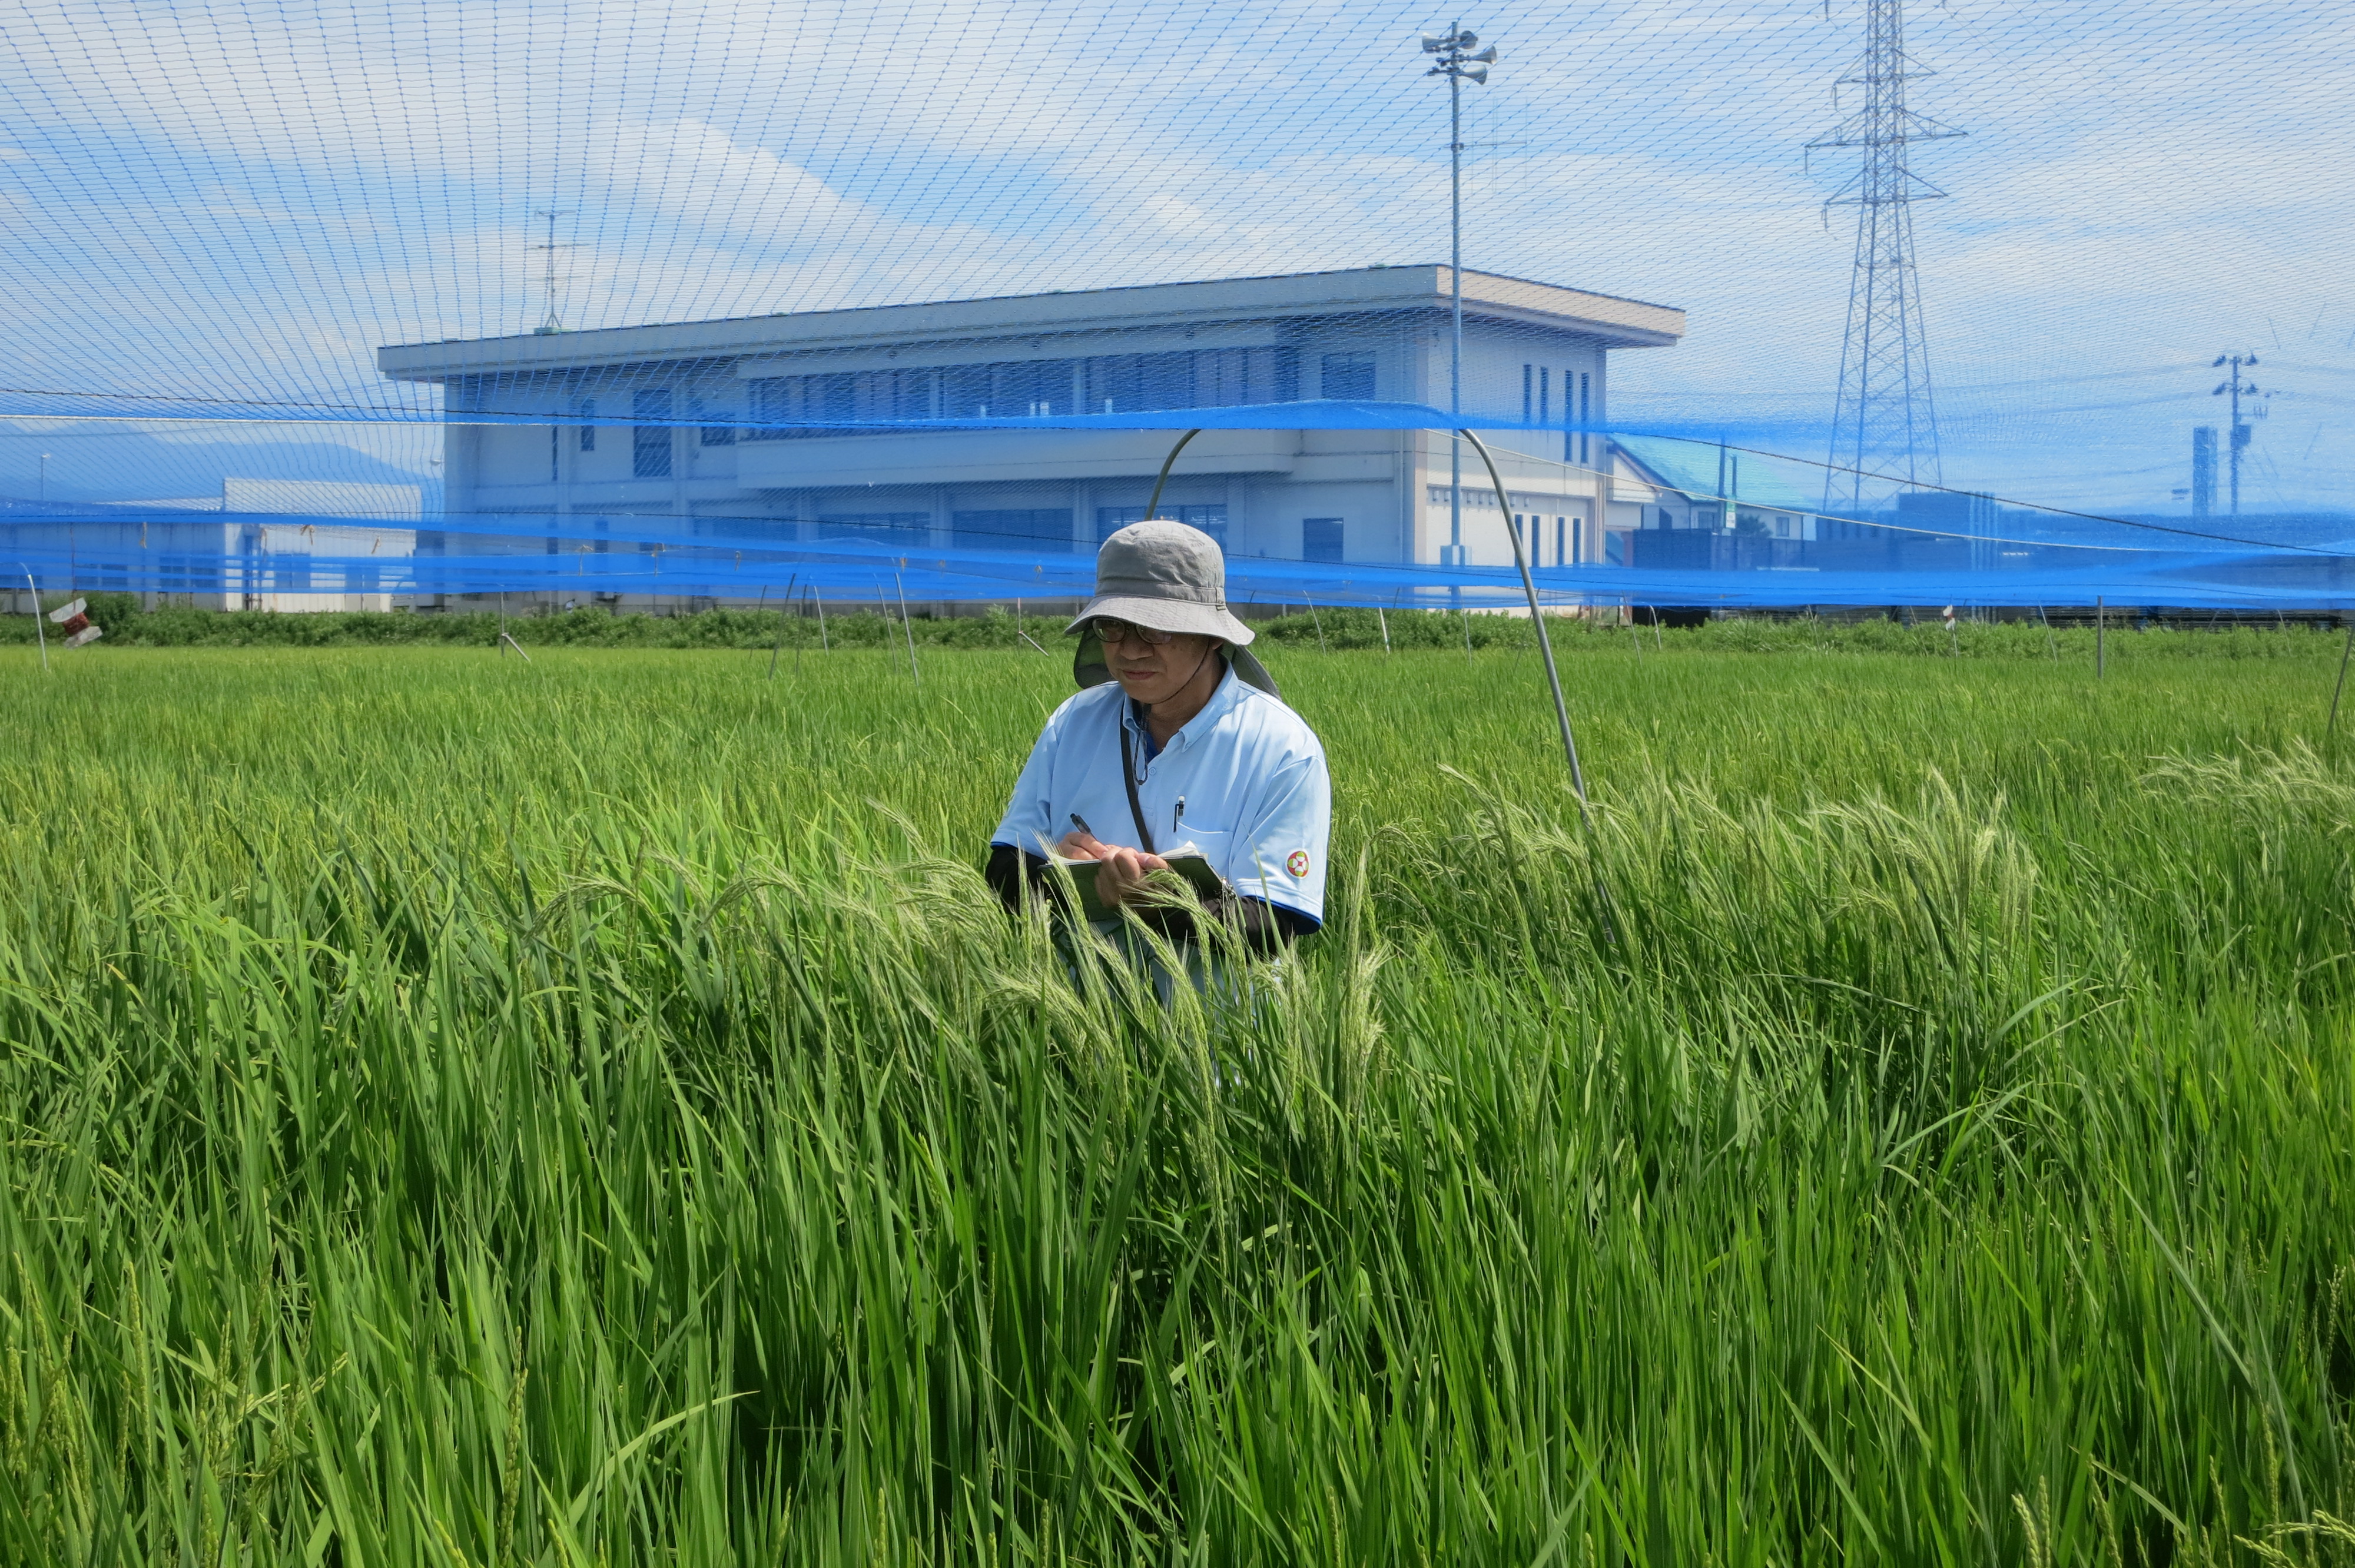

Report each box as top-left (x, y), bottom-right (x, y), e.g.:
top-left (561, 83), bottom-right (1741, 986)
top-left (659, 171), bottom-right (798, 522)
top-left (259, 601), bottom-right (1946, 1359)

top-left (0, 0), bottom-right (2355, 513)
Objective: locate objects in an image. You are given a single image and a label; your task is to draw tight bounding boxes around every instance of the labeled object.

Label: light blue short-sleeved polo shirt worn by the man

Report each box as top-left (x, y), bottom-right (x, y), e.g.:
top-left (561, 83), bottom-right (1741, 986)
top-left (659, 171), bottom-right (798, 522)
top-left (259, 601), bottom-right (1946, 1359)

top-left (989, 669), bottom-right (1333, 925)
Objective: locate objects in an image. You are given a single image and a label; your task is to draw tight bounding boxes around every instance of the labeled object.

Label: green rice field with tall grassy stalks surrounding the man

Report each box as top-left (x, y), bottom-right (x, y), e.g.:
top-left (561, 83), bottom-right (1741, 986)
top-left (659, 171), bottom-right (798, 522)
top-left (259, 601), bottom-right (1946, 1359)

top-left (0, 617), bottom-right (2355, 1568)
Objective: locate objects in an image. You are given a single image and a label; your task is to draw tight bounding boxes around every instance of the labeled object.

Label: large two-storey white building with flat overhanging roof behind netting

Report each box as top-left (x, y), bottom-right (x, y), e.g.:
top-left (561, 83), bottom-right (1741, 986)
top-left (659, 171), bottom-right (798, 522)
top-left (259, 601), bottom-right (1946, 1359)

top-left (377, 266), bottom-right (1684, 596)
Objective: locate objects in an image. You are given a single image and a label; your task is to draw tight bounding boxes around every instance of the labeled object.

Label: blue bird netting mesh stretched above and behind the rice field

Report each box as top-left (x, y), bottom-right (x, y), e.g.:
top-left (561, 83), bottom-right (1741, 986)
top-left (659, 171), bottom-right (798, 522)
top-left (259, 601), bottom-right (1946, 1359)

top-left (0, 0), bottom-right (2355, 612)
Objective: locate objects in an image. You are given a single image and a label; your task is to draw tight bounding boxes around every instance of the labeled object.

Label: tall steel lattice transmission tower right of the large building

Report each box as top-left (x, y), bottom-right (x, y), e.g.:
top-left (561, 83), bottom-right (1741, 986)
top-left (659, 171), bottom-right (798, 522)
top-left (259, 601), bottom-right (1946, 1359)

top-left (1806, 0), bottom-right (1964, 513)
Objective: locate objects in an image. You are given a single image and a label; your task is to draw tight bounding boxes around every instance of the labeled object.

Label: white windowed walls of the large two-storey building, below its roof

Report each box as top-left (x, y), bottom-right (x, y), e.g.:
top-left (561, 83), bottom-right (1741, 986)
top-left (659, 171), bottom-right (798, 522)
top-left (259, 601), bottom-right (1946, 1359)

top-left (445, 292), bottom-right (1639, 586)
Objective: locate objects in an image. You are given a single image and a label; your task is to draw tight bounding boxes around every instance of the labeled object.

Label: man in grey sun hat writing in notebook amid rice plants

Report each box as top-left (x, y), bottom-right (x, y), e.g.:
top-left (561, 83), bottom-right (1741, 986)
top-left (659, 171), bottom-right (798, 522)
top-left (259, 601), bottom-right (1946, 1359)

top-left (989, 520), bottom-right (1333, 951)
